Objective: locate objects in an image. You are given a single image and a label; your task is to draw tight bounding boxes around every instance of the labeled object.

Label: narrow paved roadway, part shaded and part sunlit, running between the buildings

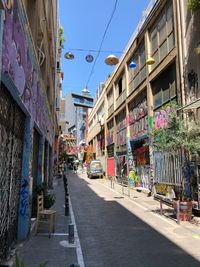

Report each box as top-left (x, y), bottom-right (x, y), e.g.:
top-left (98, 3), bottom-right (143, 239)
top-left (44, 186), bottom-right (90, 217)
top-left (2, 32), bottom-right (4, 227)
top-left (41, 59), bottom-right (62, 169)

top-left (67, 172), bottom-right (200, 267)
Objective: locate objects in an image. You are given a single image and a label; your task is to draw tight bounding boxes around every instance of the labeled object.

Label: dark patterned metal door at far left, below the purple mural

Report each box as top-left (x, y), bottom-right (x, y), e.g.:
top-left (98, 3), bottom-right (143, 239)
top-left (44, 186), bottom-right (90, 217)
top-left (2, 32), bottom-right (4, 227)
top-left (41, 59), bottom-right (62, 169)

top-left (0, 85), bottom-right (25, 259)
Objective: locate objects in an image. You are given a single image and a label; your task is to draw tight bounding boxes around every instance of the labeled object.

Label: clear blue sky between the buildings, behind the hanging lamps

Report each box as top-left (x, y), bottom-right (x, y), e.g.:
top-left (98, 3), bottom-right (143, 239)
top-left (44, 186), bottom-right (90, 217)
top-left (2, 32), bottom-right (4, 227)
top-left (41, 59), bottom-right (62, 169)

top-left (59, 0), bottom-right (149, 96)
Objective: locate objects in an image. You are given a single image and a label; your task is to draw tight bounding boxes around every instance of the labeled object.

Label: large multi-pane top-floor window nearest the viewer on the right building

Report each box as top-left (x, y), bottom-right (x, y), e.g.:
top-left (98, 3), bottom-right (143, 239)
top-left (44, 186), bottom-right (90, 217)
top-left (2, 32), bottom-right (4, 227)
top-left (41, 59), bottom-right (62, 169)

top-left (150, 1), bottom-right (174, 68)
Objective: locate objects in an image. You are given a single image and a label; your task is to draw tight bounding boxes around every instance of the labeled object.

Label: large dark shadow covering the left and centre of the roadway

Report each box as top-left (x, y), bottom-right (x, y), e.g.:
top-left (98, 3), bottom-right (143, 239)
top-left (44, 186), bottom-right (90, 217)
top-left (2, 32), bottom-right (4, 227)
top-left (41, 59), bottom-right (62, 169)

top-left (67, 172), bottom-right (200, 267)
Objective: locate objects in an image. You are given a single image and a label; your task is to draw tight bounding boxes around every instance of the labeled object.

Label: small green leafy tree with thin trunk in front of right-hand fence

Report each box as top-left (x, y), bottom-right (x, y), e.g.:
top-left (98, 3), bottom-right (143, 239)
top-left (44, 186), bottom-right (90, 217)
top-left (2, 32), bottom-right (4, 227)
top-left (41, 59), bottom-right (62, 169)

top-left (152, 113), bottom-right (200, 199)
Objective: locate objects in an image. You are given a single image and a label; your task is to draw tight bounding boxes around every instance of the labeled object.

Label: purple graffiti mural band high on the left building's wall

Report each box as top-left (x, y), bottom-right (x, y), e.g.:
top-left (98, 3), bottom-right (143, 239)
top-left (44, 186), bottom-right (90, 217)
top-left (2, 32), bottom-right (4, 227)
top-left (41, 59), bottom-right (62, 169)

top-left (2, 1), bottom-right (52, 143)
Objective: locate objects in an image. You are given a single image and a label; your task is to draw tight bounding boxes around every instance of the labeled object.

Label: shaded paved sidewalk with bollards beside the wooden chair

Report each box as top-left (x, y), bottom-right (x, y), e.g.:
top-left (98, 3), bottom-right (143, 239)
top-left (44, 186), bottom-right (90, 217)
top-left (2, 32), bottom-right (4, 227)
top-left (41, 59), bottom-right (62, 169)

top-left (18, 178), bottom-right (79, 267)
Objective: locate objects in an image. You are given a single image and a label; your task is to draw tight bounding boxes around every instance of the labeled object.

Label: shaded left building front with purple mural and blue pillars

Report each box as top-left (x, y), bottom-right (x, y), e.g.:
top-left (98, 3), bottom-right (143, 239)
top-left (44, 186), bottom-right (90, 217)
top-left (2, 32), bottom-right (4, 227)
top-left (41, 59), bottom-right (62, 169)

top-left (0, 0), bottom-right (58, 260)
